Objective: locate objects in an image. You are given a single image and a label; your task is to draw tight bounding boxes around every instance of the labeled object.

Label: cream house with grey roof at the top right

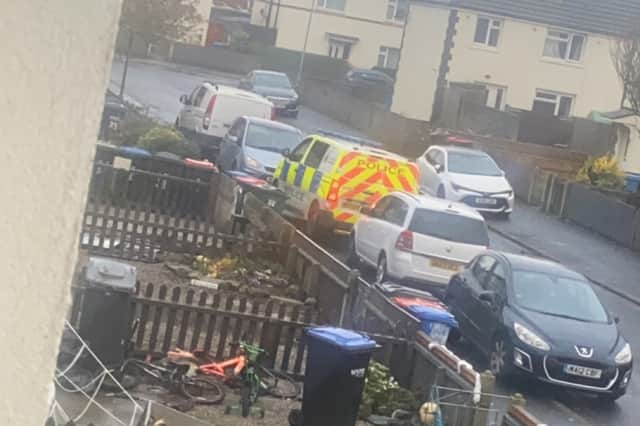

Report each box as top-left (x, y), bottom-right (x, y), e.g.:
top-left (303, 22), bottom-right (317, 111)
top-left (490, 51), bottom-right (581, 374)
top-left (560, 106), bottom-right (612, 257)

top-left (392, 0), bottom-right (640, 120)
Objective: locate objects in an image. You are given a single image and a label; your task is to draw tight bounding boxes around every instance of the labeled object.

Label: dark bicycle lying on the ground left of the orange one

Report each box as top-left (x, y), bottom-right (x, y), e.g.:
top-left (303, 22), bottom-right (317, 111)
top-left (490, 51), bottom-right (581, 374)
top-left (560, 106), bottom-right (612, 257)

top-left (120, 358), bottom-right (225, 405)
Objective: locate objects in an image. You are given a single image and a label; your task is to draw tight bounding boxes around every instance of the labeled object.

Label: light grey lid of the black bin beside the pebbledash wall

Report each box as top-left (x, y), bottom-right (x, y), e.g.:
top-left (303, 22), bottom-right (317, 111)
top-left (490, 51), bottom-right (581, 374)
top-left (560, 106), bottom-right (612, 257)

top-left (85, 257), bottom-right (136, 293)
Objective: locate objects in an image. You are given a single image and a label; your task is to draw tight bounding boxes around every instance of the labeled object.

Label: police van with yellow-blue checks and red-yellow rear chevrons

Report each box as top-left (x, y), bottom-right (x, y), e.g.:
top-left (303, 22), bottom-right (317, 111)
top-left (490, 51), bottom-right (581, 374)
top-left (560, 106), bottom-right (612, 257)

top-left (273, 132), bottom-right (419, 236)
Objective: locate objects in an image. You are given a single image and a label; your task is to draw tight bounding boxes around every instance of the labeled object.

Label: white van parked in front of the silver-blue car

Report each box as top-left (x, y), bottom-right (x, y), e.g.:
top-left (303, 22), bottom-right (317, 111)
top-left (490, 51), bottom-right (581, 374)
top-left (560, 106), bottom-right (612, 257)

top-left (175, 82), bottom-right (275, 158)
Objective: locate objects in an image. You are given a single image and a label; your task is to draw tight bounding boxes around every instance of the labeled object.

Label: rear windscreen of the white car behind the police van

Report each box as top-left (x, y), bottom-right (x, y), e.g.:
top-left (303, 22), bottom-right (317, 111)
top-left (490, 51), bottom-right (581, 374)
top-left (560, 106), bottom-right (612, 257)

top-left (409, 209), bottom-right (489, 247)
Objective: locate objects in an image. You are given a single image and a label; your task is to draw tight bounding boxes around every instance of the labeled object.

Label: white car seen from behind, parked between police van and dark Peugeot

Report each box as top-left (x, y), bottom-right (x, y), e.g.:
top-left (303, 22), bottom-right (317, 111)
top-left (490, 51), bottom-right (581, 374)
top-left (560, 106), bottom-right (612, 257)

top-left (348, 192), bottom-right (489, 291)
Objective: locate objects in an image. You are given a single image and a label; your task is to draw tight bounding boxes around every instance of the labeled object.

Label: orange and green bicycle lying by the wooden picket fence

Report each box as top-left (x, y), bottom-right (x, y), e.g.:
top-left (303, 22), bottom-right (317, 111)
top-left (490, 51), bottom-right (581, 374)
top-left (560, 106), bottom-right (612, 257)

top-left (167, 341), bottom-right (300, 415)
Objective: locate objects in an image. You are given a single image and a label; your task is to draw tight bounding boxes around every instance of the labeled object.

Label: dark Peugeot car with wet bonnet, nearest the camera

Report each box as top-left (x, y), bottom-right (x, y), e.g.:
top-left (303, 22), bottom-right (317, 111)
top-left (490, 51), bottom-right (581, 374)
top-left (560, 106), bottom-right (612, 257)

top-left (445, 251), bottom-right (632, 402)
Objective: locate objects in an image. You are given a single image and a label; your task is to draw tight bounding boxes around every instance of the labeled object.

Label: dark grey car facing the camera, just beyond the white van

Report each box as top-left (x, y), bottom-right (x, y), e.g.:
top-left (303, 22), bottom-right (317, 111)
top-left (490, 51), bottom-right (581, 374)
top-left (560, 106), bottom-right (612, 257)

top-left (239, 70), bottom-right (299, 118)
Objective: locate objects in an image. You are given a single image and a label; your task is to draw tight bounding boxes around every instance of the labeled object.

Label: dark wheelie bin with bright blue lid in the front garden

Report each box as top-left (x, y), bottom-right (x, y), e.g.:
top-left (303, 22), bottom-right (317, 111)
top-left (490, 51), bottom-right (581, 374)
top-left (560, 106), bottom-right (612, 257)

top-left (300, 327), bottom-right (376, 426)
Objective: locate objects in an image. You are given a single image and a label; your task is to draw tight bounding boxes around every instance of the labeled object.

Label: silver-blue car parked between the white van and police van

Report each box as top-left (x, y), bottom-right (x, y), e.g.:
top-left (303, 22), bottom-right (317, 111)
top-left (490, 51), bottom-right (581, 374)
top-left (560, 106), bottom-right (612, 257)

top-left (218, 116), bottom-right (302, 178)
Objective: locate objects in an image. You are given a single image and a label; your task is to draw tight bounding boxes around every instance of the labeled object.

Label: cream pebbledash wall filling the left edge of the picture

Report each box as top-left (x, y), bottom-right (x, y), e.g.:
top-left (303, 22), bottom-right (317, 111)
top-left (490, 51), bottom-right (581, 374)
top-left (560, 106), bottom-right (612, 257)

top-left (0, 0), bottom-right (121, 426)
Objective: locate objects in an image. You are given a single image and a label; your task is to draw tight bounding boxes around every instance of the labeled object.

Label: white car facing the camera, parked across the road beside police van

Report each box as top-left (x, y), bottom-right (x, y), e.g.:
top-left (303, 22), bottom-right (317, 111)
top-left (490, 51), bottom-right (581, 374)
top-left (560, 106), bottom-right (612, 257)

top-left (416, 145), bottom-right (514, 216)
